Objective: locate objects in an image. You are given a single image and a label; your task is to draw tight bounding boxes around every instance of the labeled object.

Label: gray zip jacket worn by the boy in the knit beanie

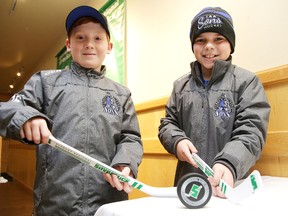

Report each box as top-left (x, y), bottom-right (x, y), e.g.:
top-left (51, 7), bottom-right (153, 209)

top-left (158, 61), bottom-right (270, 185)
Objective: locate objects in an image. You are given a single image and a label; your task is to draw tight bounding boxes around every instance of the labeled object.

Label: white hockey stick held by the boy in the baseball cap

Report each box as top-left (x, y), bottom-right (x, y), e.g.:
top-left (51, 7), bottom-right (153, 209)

top-left (48, 136), bottom-right (178, 197)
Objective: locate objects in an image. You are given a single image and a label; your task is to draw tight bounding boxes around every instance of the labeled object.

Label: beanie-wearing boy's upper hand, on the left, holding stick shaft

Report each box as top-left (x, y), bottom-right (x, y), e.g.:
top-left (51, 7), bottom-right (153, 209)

top-left (176, 139), bottom-right (198, 168)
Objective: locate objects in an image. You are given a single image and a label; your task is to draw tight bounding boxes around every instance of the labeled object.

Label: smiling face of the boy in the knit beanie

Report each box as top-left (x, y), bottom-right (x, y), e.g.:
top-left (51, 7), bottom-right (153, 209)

top-left (193, 32), bottom-right (231, 72)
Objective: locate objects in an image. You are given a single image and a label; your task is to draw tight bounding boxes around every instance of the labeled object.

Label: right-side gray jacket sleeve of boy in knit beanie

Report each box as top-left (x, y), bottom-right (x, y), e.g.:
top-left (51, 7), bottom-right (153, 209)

top-left (213, 76), bottom-right (270, 180)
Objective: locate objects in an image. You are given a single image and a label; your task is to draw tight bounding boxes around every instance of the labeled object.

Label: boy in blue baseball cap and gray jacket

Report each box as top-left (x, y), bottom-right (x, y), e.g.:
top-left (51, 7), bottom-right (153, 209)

top-left (0, 6), bottom-right (143, 216)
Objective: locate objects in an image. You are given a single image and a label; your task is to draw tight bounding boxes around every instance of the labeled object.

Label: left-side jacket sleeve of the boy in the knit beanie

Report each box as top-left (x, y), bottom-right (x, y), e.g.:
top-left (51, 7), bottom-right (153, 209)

top-left (158, 83), bottom-right (190, 157)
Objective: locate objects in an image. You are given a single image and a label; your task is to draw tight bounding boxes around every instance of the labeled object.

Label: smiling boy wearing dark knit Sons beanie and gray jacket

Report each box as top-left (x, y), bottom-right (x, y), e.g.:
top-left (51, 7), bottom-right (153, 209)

top-left (158, 7), bottom-right (270, 197)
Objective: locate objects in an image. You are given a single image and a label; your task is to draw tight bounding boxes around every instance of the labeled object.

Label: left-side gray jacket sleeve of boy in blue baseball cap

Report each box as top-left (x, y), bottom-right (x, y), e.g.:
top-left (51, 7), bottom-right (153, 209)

top-left (0, 72), bottom-right (52, 142)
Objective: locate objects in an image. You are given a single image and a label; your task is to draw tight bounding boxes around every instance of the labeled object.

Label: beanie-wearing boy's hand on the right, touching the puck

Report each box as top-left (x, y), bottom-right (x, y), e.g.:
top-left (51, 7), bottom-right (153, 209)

top-left (208, 163), bottom-right (234, 198)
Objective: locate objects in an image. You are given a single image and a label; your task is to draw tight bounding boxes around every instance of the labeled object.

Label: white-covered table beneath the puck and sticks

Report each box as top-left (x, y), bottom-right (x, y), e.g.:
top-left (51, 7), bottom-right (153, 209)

top-left (95, 176), bottom-right (288, 216)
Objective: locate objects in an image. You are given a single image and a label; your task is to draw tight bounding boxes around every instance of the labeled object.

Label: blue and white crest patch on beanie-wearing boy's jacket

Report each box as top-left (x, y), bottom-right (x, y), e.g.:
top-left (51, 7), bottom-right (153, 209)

top-left (214, 94), bottom-right (233, 119)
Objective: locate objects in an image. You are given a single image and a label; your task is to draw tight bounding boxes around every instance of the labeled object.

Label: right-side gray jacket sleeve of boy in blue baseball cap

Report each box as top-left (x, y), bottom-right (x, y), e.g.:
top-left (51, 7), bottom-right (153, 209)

top-left (111, 94), bottom-right (143, 178)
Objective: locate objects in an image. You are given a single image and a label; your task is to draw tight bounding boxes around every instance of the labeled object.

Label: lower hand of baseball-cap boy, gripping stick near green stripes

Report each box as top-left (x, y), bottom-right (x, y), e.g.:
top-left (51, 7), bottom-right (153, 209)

top-left (103, 166), bottom-right (133, 193)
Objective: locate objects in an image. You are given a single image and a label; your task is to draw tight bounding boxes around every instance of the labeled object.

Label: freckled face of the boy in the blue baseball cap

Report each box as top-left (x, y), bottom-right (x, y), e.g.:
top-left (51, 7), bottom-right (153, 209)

top-left (66, 22), bottom-right (112, 71)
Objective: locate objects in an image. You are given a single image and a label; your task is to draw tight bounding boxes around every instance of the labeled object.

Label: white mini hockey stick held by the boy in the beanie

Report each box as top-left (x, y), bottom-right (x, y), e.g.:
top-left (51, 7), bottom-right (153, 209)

top-left (192, 153), bottom-right (263, 203)
